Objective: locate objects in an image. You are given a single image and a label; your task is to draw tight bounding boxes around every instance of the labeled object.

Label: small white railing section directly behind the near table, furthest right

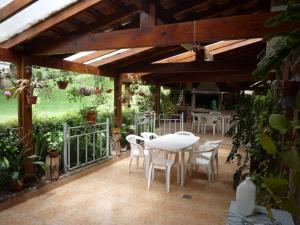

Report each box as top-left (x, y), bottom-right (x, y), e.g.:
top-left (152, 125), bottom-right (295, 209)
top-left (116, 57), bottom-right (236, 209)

top-left (158, 113), bottom-right (184, 135)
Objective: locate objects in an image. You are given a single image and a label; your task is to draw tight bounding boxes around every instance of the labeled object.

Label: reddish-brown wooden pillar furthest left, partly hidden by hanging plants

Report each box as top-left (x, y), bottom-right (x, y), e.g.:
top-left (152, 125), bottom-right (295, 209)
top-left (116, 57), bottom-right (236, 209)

top-left (18, 57), bottom-right (34, 174)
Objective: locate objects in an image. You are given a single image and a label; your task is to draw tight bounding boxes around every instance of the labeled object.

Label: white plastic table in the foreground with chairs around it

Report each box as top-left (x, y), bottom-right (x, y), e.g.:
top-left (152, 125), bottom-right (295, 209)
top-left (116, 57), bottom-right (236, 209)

top-left (145, 134), bottom-right (200, 186)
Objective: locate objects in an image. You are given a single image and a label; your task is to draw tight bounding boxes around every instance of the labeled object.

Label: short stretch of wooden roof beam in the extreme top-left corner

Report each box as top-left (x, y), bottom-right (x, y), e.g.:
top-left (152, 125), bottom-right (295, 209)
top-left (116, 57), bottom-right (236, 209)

top-left (0, 0), bottom-right (37, 22)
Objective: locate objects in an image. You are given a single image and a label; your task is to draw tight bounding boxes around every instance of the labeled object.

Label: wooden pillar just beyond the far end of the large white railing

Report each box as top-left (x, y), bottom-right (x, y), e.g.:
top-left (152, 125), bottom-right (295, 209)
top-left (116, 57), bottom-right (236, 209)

top-left (114, 74), bottom-right (122, 128)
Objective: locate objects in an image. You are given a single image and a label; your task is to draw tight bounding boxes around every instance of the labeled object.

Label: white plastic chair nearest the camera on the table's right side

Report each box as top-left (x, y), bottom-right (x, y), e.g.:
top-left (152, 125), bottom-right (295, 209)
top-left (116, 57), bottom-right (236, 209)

top-left (187, 145), bottom-right (218, 186)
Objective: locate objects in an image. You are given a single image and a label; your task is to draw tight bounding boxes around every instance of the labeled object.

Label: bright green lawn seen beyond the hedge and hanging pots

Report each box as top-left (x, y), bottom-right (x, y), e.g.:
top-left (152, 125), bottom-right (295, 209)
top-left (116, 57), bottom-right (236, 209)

top-left (0, 75), bottom-right (113, 123)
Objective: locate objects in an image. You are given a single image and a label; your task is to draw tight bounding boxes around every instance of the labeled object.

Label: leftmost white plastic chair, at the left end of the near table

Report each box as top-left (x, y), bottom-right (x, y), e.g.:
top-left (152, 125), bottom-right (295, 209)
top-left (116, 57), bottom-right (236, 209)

top-left (126, 134), bottom-right (145, 174)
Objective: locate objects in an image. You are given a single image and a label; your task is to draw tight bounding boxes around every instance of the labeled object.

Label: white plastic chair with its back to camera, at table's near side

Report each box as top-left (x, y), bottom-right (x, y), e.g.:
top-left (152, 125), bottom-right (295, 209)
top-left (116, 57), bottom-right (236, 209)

top-left (148, 149), bottom-right (175, 192)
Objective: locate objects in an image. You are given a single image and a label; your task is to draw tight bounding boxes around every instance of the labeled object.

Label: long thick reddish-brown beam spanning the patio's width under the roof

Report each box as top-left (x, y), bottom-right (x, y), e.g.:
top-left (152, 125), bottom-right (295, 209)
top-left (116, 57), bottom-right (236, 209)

top-left (32, 13), bottom-right (299, 54)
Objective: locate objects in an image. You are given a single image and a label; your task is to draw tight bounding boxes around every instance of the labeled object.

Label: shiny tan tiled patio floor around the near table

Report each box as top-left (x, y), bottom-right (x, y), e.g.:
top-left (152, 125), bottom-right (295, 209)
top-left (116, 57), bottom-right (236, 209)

top-left (0, 143), bottom-right (234, 225)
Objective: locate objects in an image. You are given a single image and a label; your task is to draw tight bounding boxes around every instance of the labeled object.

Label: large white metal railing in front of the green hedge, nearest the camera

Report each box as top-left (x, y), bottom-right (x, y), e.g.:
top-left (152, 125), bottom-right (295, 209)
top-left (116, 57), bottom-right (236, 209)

top-left (64, 119), bottom-right (109, 172)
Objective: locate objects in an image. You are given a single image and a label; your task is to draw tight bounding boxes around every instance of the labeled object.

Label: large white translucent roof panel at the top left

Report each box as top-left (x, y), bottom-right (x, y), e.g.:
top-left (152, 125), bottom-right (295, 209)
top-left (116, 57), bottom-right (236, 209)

top-left (0, 0), bottom-right (78, 43)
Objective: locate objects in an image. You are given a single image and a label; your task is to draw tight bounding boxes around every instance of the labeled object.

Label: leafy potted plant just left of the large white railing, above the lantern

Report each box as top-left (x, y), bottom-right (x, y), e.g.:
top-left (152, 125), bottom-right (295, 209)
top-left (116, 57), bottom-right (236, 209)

top-left (45, 131), bottom-right (64, 158)
